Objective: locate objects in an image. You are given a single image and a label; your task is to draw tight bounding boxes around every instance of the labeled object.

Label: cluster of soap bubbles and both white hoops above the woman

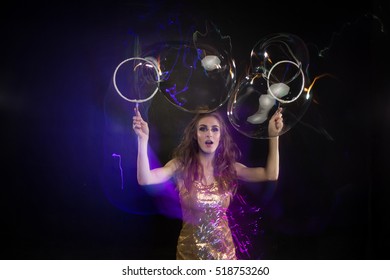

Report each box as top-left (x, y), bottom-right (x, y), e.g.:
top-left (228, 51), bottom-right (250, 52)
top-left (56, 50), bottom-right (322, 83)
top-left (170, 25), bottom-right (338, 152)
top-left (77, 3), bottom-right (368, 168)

top-left (114, 29), bottom-right (312, 139)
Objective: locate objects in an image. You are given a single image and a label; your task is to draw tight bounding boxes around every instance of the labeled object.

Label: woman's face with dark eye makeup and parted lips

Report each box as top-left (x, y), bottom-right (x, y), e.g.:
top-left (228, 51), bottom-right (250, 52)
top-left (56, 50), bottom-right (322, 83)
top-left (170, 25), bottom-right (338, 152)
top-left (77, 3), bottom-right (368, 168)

top-left (196, 116), bottom-right (221, 154)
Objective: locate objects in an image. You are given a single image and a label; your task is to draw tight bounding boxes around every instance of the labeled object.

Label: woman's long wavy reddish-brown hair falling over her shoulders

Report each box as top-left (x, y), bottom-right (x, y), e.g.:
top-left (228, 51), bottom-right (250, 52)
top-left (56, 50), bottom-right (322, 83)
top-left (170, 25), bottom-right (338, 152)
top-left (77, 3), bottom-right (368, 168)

top-left (173, 112), bottom-right (241, 195)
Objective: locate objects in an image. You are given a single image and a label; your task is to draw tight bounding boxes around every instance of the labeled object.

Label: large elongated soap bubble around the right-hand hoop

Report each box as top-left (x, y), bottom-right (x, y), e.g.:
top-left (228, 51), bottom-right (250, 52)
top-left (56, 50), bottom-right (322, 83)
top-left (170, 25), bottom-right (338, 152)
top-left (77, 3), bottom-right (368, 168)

top-left (228, 33), bottom-right (311, 139)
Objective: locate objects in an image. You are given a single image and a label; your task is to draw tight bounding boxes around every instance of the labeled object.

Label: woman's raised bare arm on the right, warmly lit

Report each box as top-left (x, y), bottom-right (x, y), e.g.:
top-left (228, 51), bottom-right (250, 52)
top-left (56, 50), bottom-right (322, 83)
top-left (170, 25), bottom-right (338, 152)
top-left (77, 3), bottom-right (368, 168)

top-left (236, 108), bottom-right (283, 182)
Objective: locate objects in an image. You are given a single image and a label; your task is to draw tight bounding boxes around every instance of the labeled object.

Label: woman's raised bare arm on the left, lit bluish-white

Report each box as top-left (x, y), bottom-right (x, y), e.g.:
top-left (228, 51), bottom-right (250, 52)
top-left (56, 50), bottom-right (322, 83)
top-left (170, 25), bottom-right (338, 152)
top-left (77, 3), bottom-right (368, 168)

top-left (133, 107), bottom-right (176, 185)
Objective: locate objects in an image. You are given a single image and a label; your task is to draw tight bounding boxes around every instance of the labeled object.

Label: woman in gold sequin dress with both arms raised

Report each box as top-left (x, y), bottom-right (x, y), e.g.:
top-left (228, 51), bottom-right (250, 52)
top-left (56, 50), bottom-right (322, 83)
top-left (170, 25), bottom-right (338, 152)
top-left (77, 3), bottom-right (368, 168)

top-left (133, 108), bottom-right (283, 260)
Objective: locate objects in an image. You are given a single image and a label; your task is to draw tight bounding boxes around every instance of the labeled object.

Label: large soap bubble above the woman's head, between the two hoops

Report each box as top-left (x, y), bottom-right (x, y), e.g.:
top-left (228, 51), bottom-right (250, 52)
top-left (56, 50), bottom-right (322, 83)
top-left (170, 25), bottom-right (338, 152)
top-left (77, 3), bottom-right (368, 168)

top-left (143, 22), bottom-right (236, 113)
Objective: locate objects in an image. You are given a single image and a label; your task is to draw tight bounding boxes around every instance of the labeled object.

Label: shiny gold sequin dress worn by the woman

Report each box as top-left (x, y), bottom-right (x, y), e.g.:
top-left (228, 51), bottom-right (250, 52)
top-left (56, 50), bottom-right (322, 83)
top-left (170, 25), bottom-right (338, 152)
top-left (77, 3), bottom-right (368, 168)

top-left (176, 181), bottom-right (236, 260)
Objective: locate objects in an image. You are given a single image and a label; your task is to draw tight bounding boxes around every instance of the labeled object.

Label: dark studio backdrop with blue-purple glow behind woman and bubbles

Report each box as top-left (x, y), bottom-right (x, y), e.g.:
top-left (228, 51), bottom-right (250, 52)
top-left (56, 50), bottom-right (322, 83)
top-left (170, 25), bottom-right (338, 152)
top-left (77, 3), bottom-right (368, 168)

top-left (0, 1), bottom-right (390, 260)
